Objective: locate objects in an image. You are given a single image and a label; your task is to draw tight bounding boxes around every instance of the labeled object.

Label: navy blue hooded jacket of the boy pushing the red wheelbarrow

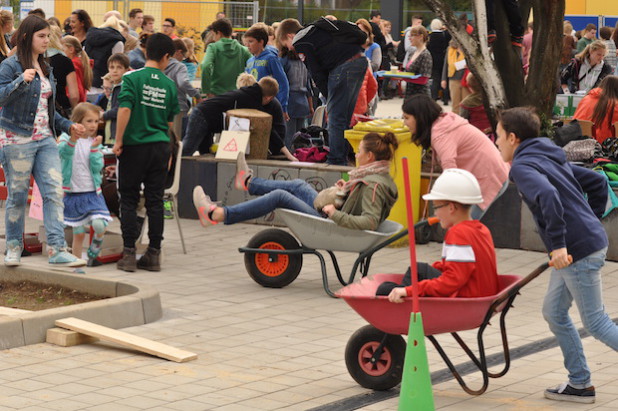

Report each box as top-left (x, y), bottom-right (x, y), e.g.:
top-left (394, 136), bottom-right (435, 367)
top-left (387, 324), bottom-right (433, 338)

top-left (510, 137), bottom-right (608, 261)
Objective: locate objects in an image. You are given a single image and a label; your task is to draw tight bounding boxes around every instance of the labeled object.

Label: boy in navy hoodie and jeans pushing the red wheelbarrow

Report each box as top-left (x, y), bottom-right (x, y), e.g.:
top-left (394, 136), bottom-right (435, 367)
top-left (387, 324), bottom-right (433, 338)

top-left (496, 107), bottom-right (618, 403)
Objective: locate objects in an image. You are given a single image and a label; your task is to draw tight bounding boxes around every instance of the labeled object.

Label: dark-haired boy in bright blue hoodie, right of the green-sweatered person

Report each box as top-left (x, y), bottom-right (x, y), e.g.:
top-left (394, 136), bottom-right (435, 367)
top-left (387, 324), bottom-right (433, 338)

top-left (243, 26), bottom-right (290, 116)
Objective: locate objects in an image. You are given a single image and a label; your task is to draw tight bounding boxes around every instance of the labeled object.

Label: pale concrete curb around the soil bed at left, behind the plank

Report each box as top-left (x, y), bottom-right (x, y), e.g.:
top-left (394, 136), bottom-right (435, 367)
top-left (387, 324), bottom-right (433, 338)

top-left (0, 267), bottom-right (163, 349)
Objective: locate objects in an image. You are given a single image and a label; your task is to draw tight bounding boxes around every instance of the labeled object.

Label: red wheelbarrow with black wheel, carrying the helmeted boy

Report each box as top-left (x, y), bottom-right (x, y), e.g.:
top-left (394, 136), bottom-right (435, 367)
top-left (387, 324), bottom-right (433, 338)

top-left (336, 263), bottom-right (548, 395)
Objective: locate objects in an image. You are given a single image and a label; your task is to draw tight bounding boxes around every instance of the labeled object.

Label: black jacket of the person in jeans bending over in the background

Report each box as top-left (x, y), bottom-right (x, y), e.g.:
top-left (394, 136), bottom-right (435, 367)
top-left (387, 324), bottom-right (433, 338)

top-left (294, 18), bottom-right (367, 97)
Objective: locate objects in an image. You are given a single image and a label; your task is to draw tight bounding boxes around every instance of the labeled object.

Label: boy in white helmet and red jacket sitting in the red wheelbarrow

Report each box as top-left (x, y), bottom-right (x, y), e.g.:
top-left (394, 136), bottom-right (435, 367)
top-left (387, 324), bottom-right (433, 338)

top-left (376, 168), bottom-right (498, 303)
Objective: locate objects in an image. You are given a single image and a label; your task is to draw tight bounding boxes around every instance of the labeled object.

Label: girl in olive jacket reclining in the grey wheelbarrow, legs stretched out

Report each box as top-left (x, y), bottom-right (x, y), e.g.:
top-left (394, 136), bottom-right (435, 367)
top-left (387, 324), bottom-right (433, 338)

top-left (193, 133), bottom-right (398, 230)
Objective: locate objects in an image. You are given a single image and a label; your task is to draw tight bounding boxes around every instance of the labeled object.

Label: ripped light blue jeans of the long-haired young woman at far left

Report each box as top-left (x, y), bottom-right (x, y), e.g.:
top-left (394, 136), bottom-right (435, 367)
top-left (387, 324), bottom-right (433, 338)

top-left (0, 137), bottom-right (65, 248)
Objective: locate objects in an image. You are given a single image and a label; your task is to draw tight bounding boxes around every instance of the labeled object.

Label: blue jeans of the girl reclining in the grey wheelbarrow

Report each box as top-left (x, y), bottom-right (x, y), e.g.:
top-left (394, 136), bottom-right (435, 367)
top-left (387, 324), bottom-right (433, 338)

top-left (223, 177), bottom-right (320, 224)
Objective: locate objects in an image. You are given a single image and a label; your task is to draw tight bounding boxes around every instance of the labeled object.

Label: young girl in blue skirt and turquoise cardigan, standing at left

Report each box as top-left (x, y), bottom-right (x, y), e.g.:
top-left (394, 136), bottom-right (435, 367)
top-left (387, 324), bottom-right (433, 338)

top-left (58, 103), bottom-right (112, 267)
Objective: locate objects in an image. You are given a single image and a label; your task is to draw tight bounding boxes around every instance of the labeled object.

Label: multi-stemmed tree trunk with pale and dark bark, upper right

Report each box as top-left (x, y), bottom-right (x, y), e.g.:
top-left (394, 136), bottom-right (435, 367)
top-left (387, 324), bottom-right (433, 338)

top-left (423, 0), bottom-right (565, 124)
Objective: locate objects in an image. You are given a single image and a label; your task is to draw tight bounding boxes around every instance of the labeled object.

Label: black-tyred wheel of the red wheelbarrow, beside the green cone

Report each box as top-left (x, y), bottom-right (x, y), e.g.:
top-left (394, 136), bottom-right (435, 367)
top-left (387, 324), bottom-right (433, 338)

top-left (345, 325), bottom-right (406, 391)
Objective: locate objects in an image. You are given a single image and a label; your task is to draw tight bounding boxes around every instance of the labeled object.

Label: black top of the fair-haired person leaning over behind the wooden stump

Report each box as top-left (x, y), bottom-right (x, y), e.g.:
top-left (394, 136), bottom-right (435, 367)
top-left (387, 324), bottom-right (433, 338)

top-left (195, 84), bottom-right (285, 154)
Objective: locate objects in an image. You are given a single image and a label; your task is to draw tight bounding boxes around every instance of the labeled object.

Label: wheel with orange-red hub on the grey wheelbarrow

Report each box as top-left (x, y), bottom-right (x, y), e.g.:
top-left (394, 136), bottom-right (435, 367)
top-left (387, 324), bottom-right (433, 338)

top-left (245, 228), bottom-right (303, 288)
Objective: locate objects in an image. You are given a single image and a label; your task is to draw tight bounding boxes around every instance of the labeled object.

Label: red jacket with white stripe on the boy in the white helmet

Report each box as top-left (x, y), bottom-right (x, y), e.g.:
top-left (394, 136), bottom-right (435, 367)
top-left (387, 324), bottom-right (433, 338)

top-left (406, 220), bottom-right (498, 297)
